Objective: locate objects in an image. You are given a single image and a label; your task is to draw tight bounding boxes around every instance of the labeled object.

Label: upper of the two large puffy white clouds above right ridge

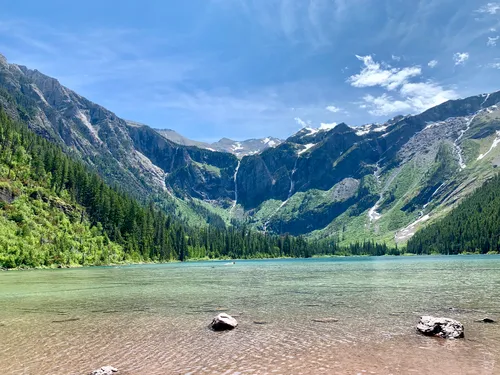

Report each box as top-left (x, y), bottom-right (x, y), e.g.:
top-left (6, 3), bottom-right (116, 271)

top-left (347, 55), bottom-right (422, 90)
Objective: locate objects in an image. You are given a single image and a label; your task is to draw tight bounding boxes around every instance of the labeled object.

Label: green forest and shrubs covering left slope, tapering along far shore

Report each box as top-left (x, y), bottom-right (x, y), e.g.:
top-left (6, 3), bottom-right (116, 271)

top-left (0, 109), bottom-right (392, 268)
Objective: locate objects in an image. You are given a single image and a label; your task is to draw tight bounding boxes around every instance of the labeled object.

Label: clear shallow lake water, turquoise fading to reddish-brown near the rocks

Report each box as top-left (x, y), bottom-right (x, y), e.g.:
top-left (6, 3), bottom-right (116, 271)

top-left (0, 256), bottom-right (500, 375)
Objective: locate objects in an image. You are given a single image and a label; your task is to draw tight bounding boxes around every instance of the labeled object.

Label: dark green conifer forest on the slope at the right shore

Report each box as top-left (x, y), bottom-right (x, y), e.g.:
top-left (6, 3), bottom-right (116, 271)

top-left (407, 175), bottom-right (500, 254)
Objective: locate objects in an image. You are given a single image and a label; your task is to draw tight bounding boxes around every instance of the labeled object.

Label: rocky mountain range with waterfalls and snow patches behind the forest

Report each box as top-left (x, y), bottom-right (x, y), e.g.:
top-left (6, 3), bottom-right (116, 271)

top-left (0, 53), bottom-right (500, 244)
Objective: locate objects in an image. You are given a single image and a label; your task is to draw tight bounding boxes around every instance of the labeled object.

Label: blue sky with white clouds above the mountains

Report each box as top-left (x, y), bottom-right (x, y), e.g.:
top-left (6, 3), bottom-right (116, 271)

top-left (0, 0), bottom-right (500, 142)
